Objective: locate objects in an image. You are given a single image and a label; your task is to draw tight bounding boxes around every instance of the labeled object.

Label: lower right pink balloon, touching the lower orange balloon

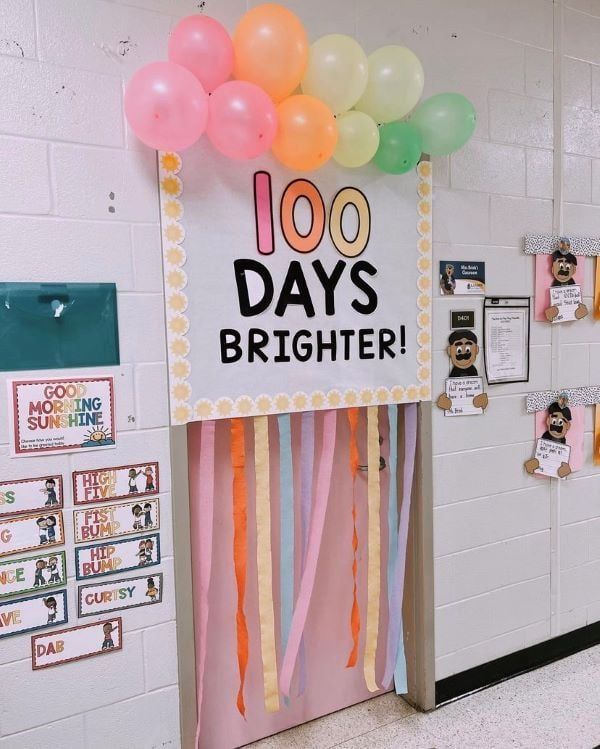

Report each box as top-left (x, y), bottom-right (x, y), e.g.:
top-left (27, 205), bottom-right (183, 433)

top-left (207, 81), bottom-right (277, 160)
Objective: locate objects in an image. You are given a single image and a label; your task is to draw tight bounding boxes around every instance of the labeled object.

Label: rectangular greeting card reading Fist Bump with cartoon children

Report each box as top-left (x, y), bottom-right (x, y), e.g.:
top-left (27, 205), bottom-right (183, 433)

top-left (73, 497), bottom-right (160, 544)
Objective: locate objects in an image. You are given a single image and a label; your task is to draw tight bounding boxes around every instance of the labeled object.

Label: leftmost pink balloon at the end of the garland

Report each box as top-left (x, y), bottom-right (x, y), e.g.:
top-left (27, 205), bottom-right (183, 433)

top-left (125, 62), bottom-right (208, 151)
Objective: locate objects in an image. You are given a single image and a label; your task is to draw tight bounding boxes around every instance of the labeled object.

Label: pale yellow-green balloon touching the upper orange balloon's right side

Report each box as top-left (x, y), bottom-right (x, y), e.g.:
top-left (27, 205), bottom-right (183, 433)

top-left (302, 34), bottom-right (369, 114)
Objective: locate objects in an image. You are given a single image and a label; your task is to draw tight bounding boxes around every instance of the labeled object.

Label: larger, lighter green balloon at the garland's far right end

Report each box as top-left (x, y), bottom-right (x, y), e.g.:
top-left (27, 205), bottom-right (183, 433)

top-left (410, 94), bottom-right (477, 156)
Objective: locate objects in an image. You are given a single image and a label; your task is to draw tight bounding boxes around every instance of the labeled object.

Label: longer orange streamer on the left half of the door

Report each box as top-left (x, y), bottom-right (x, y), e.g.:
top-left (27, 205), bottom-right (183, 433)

top-left (230, 419), bottom-right (248, 717)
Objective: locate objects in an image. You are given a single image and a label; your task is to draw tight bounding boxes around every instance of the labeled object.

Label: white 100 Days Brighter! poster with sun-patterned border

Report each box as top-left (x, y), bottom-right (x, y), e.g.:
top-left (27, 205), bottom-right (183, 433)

top-left (159, 150), bottom-right (432, 423)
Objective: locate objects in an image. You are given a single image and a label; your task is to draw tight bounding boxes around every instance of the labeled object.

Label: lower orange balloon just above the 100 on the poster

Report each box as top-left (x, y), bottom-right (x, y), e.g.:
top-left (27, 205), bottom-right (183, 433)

top-left (272, 94), bottom-right (338, 171)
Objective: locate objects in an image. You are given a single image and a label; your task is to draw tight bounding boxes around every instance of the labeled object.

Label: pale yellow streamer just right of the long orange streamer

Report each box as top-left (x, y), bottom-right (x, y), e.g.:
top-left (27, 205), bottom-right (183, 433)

top-left (254, 416), bottom-right (279, 713)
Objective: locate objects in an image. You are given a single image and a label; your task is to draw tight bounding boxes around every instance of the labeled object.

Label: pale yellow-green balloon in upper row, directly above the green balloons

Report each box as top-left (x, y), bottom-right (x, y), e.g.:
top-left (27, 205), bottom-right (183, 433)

top-left (356, 45), bottom-right (425, 123)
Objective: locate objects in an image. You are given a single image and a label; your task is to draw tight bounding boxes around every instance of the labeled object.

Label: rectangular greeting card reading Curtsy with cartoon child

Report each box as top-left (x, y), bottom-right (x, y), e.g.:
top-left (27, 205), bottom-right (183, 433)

top-left (77, 572), bottom-right (163, 617)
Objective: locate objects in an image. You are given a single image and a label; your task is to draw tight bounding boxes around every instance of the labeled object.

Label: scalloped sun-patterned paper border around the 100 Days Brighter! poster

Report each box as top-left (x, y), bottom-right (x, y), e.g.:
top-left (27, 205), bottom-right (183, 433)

top-left (158, 151), bottom-right (433, 424)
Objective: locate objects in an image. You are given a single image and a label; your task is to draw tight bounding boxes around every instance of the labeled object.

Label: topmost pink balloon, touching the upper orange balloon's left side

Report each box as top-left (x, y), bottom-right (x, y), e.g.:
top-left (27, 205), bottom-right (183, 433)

top-left (169, 16), bottom-right (233, 93)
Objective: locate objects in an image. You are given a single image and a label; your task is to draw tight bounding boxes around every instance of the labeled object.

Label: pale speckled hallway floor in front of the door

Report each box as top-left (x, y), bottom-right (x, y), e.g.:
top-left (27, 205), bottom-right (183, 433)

top-left (249, 646), bottom-right (600, 749)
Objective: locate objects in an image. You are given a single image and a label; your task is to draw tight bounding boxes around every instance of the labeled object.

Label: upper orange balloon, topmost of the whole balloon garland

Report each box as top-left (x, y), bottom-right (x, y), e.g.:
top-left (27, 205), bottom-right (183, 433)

top-left (233, 3), bottom-right (308, 102)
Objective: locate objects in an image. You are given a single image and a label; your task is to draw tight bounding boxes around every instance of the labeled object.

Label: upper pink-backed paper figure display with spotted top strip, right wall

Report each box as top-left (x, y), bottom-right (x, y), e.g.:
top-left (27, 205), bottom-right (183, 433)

top-left (525, 234), bottom-right (600, 323)
